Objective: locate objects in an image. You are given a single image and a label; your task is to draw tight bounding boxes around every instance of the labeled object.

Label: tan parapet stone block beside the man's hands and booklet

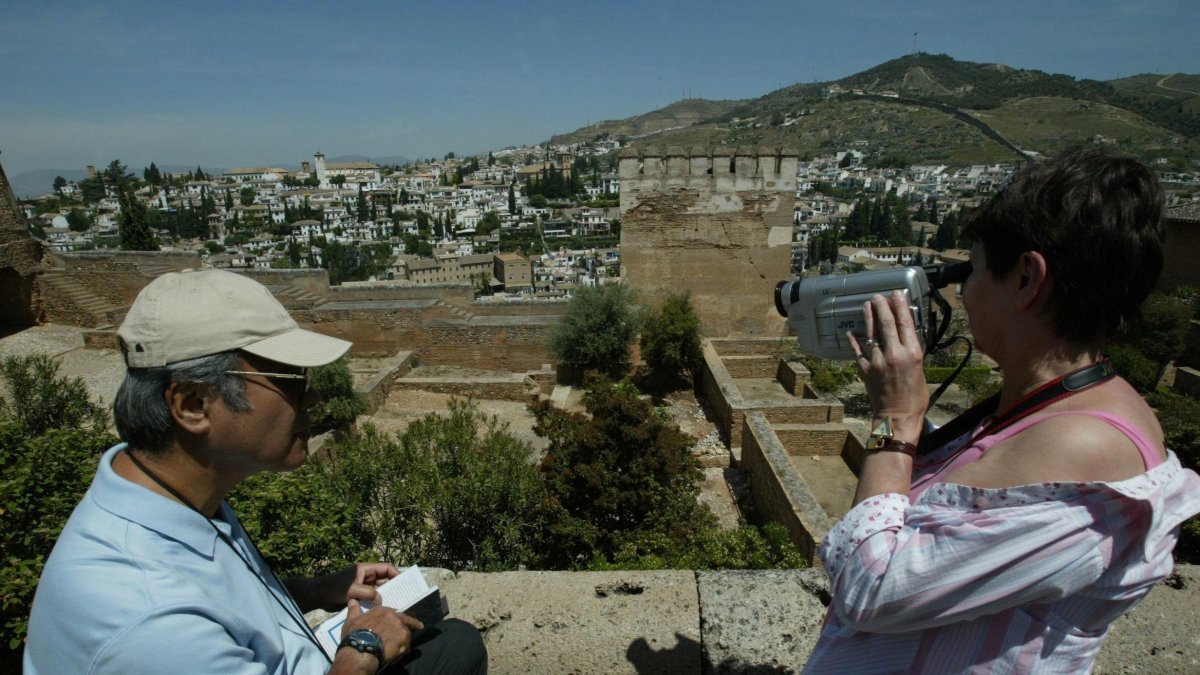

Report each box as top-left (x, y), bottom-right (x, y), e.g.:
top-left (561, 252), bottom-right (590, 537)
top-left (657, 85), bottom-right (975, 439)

top-left (441, 571), bottom-right (702, 675)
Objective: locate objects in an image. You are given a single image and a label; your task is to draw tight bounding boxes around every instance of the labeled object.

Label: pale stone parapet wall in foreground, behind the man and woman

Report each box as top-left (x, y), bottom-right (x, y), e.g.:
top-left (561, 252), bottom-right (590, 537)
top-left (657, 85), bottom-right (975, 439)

top-left (403, 565), bottom-right (1200, 675)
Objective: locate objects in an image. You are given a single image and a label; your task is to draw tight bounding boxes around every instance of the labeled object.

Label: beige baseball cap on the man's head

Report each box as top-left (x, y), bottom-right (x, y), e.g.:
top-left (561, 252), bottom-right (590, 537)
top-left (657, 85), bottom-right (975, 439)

top-left (116, 269), bottom-right (350, 368)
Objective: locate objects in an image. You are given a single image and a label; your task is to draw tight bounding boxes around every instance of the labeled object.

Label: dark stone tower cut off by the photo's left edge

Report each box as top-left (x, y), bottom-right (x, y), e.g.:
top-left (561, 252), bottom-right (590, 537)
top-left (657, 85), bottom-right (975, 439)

top-left (0, 154), bottom-right (44, 327)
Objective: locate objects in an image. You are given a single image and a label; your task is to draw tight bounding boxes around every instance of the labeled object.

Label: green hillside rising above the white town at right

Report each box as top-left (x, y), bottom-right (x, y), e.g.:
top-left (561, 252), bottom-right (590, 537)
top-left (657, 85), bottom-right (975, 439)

top-left (554, 54), bottom-right (1200, 163)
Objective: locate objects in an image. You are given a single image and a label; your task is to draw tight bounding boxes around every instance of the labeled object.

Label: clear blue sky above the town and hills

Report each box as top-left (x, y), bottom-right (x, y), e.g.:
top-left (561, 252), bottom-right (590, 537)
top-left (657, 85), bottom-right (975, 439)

top-left (0, 0), bottom-right (1200, 177)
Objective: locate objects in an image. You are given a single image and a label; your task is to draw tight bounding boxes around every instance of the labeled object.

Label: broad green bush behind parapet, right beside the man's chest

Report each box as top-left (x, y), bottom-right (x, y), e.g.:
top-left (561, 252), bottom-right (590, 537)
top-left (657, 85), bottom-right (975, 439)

top-left (230, 400), bottom-right (540, 577)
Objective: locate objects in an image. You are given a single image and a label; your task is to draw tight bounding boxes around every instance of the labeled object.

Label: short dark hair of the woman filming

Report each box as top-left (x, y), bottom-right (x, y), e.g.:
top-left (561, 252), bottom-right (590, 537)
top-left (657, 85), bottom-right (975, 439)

top-left (961, 148), bottom-right (1165, 347)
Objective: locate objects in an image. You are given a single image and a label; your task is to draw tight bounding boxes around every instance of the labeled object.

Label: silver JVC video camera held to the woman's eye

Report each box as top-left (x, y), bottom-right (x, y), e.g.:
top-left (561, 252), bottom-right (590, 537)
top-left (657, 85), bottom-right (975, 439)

top-left (775, 262), bottom-right (971, 360)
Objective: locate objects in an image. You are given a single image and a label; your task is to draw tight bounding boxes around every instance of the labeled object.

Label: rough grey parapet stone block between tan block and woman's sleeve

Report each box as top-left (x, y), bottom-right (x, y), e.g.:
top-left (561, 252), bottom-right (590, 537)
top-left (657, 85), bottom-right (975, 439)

top-left (696, 569), bottom-right (829, 674)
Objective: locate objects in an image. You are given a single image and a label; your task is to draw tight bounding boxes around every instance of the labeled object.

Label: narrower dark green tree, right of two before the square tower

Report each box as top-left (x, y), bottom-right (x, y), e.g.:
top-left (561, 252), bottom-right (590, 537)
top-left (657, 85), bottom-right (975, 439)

top-left (641, 292), bottom-right (702, 381)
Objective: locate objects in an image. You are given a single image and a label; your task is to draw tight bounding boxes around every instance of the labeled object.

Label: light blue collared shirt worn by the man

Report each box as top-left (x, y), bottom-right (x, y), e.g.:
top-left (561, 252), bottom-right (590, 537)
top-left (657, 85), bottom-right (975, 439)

top-left (24, 443), bottom-right (329, 675)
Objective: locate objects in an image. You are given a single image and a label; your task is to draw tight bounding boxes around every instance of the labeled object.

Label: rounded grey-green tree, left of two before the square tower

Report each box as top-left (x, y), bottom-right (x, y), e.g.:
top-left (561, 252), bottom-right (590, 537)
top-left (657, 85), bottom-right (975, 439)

top-left (547, 283), bottom-right (640, 376)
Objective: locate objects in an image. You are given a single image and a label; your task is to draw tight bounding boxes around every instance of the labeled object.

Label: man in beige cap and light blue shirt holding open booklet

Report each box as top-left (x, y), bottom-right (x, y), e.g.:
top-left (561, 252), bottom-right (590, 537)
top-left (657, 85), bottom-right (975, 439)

top-left (24, 270), bottom-right (487, 674)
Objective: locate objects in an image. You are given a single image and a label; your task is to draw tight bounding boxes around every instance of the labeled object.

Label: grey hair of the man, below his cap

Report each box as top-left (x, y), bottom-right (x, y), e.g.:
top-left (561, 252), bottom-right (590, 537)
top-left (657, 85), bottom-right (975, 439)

top-left (113, 351), bottom-right (250, 452)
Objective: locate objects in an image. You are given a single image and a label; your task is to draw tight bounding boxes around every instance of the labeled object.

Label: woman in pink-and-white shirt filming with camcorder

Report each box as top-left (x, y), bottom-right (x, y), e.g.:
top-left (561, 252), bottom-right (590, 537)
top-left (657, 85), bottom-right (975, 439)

top-left (805, 150), bottom-right (1200, 673)
